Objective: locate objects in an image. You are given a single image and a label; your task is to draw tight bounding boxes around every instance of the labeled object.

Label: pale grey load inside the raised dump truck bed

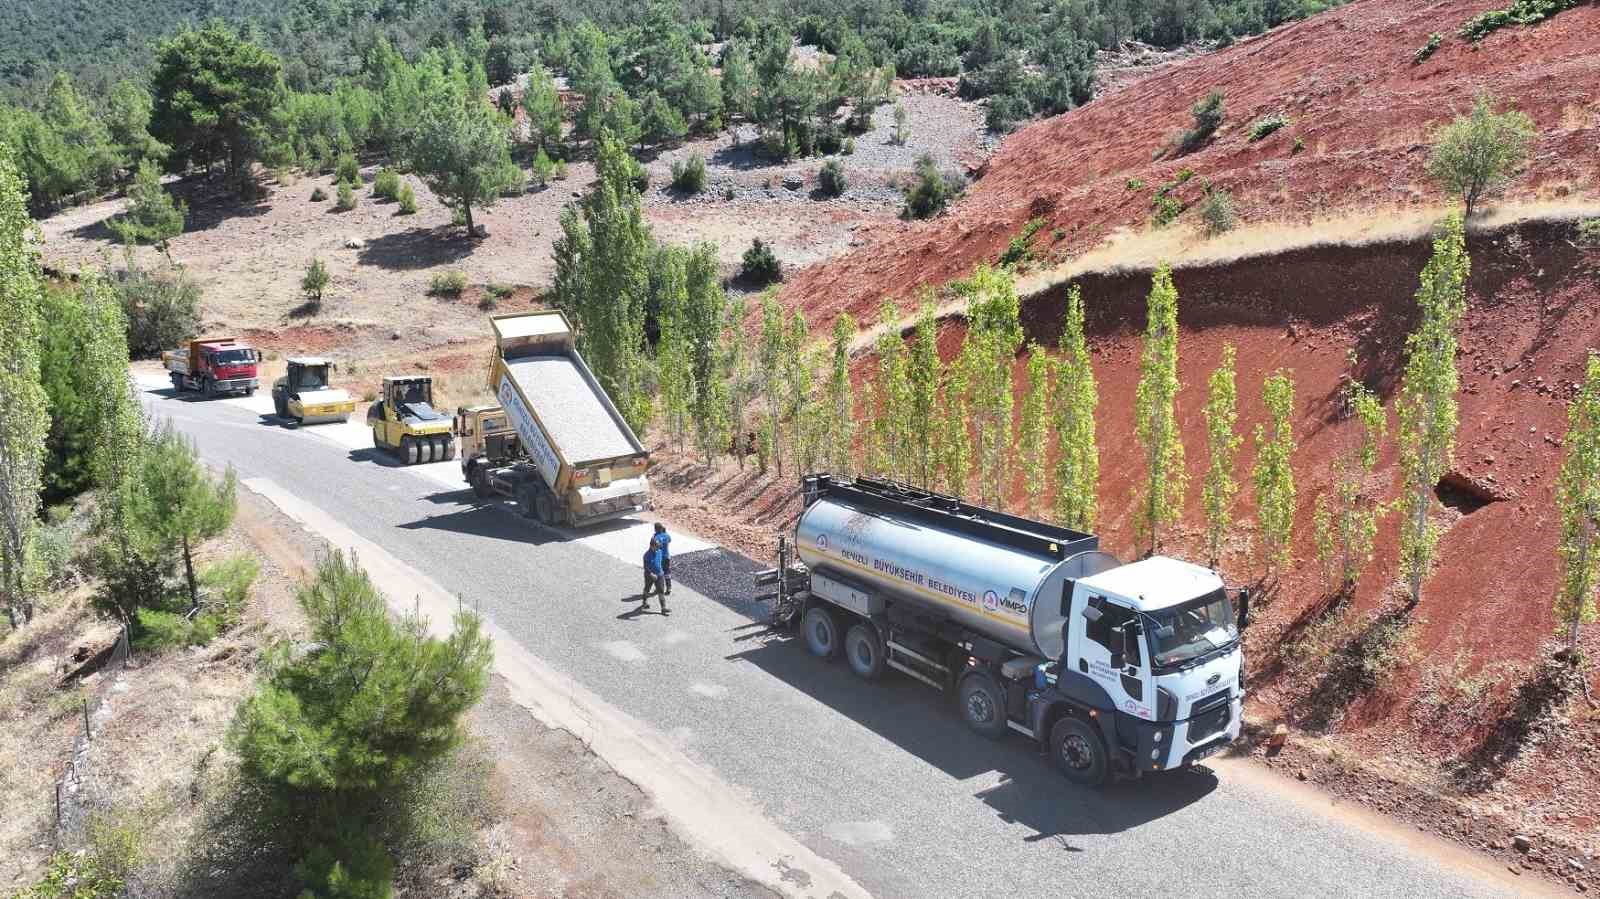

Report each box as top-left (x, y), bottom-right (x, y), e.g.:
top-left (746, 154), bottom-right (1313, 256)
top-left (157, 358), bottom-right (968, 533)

top-left (506, 355), bottom-right (640, 465)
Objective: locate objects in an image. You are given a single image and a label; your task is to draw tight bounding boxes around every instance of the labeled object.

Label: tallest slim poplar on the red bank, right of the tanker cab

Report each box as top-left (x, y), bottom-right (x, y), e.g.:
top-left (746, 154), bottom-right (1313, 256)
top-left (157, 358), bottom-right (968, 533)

top-left (1395, 214), bottom-right (1472, 608)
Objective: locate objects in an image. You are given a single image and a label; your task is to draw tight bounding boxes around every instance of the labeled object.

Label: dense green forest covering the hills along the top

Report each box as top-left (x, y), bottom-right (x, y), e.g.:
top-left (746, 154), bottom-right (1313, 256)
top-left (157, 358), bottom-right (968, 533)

top-left (0, 0), bottom-right (1342, 212)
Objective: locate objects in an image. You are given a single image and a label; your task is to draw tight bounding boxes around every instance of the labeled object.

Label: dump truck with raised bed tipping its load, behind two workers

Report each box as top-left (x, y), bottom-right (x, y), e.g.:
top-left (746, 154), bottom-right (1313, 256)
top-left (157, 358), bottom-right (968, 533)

top-left (454, 312), bottom-right (650, 528)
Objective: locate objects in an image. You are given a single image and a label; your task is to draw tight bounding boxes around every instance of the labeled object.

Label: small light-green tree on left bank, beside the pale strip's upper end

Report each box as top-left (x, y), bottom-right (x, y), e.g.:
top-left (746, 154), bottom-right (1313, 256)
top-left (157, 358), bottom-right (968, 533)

top-left (126, 426), bottom-right (237, 608)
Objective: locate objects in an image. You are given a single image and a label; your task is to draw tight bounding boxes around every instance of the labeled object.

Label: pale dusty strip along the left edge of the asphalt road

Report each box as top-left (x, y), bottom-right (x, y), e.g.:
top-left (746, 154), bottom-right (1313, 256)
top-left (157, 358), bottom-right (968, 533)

top-left (243, 478), bottom-right (870, 899)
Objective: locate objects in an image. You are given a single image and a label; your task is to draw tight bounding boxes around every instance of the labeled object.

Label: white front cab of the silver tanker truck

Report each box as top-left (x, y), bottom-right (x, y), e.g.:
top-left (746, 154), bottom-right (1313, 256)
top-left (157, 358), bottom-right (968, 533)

top-left (1038, 557), bottom-right (1243, 779)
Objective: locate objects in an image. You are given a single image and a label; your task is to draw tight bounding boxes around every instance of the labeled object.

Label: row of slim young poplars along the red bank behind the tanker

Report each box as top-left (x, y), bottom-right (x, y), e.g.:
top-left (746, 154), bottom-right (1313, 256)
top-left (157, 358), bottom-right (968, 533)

top-left (678, 214), bottom-right (1600, 645)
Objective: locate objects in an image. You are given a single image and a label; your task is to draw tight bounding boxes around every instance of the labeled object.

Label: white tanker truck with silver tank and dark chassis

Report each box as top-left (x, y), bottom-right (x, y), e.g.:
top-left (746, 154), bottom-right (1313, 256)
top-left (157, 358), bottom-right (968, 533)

top-left (757, 475), bottom-right (1248, 784)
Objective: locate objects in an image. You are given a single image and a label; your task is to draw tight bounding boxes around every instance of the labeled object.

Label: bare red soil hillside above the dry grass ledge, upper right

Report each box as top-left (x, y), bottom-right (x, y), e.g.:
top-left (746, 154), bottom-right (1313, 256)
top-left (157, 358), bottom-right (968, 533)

top-left (782, 0), bottom-right (1600, 330)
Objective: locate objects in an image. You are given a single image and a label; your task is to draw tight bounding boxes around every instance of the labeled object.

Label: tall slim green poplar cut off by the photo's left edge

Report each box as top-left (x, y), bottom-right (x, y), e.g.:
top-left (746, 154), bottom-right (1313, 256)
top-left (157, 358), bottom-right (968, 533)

top-left (0, 144), bottom-right (50, 627)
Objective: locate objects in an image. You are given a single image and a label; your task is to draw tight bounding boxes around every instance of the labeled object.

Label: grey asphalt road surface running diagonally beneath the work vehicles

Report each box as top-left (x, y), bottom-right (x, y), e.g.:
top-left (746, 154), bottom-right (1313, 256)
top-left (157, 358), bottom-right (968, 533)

top-left (141, 376), bottom-right (1533, 899)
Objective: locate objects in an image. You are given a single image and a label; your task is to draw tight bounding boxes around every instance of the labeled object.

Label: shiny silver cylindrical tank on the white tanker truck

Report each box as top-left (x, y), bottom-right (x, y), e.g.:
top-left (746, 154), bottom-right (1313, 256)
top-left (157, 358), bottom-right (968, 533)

top-left (795, 497), bottom-right (1118, 659)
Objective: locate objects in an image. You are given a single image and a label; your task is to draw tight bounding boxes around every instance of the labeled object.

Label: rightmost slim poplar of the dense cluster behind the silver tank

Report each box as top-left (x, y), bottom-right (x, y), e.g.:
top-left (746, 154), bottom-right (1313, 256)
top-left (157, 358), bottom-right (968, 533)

top-left (1054, 285), bottom-right (1099, 533)
